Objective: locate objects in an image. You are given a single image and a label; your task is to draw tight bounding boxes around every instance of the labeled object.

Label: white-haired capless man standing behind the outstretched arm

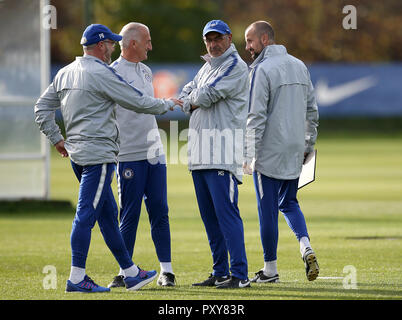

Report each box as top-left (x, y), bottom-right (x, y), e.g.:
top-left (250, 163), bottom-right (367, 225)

top-left (109, 22), bottom-right (175, 287)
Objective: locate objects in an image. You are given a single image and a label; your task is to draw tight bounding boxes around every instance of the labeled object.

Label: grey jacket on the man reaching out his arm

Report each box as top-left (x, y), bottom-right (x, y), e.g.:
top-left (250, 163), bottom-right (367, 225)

top-left (35, 55), bottom-right (174, 166)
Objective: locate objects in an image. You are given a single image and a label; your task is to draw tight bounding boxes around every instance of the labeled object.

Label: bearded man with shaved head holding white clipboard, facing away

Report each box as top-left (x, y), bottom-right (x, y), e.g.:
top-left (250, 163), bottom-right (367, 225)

top-left (243, 21), bottom-right (319, 283)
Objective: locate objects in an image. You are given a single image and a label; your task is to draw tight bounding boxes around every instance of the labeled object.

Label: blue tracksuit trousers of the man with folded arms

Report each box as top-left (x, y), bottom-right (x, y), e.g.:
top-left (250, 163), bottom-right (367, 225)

top-left (192, 169), bottom-right (248, 280)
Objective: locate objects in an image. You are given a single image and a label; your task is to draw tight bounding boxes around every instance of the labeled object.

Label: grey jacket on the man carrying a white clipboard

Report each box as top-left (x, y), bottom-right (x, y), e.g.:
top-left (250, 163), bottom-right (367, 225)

top-left (245, 45), bottom-right (318, 180)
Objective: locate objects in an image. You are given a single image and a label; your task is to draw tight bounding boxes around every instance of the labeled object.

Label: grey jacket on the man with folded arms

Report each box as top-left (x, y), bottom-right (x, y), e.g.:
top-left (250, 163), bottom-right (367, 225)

top-left (179, 44), bottom-right (249, 182)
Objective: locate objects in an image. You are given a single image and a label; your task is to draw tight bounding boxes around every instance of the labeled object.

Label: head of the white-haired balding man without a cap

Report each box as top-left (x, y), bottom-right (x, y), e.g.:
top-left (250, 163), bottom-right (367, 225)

top-left (119, 22), bottom-right (152, 62)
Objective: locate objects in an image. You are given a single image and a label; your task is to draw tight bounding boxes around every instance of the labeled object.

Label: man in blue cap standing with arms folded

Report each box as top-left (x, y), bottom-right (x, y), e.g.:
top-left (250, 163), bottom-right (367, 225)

top-left (179, 20), bottom-right (250, 289)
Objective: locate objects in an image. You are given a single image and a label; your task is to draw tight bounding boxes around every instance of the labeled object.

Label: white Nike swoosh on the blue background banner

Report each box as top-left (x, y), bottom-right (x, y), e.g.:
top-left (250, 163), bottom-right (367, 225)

top-left (315, 76), bottom-right (377, 107)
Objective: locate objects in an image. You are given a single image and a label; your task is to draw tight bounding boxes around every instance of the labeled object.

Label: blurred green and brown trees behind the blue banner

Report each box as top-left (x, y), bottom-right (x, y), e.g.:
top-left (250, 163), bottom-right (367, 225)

top-left (50, 0), bottom-right (402, 64)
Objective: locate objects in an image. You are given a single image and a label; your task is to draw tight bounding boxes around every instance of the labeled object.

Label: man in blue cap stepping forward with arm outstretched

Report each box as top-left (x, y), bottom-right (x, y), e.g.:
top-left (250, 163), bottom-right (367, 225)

top-left (35, 24), bottom-right (181, 293)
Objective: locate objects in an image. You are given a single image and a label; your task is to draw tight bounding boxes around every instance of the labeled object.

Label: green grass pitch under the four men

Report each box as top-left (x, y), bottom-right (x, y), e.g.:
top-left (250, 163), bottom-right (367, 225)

top-left (0, 135), bottom-right (402, 300)
